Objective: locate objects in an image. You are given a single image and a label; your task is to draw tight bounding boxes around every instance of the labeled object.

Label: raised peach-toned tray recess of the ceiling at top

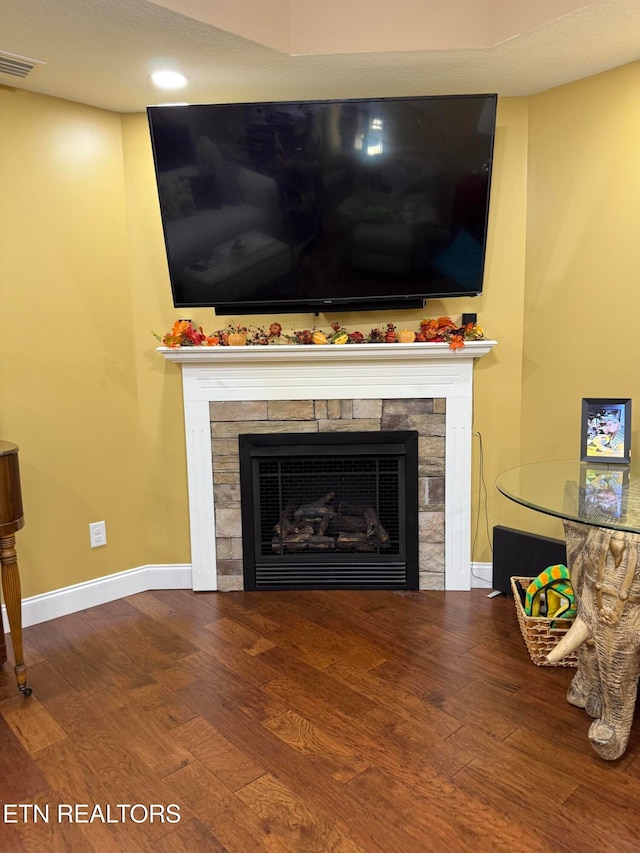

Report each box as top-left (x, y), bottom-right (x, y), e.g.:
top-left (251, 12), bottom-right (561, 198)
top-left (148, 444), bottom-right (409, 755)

top-left (151, 0), bottom-right (595, 55)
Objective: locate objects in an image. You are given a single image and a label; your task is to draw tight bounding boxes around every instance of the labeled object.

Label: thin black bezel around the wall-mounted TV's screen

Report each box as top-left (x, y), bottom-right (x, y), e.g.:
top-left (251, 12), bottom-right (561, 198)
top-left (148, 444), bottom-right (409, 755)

top-left (147, 92), bottom-right (498, 316)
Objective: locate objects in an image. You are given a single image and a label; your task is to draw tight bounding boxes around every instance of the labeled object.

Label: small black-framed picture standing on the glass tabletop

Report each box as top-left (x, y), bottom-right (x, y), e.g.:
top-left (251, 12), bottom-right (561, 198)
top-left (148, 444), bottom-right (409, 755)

top-left (580, 397), bottom-right (631, 464)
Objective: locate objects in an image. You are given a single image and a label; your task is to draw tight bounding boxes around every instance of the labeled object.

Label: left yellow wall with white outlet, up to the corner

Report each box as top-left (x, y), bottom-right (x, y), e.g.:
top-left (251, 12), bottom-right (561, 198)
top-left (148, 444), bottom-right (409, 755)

top-left (0, 87), bottom-right (145, 595)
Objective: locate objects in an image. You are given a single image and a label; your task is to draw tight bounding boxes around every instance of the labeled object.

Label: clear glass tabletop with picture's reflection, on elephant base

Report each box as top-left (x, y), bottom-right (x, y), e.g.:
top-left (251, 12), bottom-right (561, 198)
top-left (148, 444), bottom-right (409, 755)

top-left (496, 459), bottom-right (640, 533)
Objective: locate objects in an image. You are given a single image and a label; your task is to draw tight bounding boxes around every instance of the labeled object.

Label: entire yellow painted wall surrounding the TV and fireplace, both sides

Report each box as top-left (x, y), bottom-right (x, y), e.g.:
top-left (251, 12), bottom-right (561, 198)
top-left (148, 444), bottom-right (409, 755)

top-left (0, 64), bottom-right (640, 596)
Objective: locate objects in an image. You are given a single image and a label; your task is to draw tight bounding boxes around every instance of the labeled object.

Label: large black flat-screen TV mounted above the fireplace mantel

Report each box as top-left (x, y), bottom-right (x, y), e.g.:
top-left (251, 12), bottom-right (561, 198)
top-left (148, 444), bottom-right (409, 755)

top-left (147, 94), bottom-right (497, 314)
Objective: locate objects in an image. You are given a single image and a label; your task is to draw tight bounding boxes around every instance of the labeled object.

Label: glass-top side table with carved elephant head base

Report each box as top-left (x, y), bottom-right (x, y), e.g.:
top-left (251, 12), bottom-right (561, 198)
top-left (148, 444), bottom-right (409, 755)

top-left (496, 460), bottom-right (640, 760)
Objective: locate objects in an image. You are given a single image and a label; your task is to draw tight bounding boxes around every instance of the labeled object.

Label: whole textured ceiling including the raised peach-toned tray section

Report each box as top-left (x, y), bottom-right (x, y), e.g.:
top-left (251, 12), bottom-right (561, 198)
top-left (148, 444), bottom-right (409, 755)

top-left (0, 0), bottom-right (640, 113)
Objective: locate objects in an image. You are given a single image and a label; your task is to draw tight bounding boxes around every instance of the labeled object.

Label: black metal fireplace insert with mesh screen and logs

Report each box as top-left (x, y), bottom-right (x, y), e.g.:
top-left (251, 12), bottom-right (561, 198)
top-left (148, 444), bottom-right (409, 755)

top-left (239, 430), bottom-right (418, 590)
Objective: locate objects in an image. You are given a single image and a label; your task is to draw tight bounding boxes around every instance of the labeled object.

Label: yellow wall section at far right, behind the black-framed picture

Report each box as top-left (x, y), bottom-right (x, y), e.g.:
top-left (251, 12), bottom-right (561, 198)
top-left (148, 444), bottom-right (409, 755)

top-left (508, 63), bottom-right (640, 536)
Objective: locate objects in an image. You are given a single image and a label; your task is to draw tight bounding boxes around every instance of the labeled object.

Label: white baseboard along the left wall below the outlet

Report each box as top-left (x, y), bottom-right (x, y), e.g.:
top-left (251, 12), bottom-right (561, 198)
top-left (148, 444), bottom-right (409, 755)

top-left (2, 563), bottom-right (192, 631)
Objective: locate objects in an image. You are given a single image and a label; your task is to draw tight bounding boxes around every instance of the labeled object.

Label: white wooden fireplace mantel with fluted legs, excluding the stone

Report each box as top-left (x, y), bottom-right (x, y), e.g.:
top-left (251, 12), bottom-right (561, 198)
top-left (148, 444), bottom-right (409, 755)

top-left (158, 340), bottom-right (496, 591)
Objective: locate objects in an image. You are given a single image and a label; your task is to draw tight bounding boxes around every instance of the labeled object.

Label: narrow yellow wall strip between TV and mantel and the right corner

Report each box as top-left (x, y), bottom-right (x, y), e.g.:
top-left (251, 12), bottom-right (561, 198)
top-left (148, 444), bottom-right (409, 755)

top-left (470, 98), bottom-right (528, 562)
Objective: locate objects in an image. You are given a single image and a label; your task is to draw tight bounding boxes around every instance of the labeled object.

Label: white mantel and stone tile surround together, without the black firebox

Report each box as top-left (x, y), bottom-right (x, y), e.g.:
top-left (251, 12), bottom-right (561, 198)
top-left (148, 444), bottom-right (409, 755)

top-left (158, 341), bottom-right (495, 591)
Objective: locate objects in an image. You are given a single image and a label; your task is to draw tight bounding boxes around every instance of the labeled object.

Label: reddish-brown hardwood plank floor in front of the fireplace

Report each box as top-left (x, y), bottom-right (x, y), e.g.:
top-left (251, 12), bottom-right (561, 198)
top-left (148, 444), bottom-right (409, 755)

top-left (0, 590), bottom-right (640, 853)
